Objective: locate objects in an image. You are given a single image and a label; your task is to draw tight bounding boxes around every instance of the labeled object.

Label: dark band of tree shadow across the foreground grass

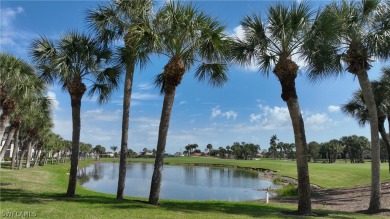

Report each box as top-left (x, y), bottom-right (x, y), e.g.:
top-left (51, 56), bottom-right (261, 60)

top-left (0, 188), bottom-right (378, 219)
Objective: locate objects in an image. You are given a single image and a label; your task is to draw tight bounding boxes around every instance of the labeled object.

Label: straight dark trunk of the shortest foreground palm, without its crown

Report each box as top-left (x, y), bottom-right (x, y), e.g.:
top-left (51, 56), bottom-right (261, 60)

top-left (66, 92), bottom-right (85, 197)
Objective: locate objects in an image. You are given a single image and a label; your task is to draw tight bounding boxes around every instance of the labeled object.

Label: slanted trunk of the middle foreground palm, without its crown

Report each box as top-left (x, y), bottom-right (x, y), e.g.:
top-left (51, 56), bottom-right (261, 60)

top-left (149, 87), bottom-right (176, 205)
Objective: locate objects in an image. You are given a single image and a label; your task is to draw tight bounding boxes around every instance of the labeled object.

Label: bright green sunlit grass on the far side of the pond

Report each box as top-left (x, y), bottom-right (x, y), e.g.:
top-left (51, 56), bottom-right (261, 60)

top-left (125, 157), bottom-right (390, 189)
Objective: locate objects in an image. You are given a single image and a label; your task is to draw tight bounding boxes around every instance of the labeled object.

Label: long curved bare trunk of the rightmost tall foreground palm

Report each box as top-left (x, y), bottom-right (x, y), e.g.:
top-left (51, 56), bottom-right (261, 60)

top-left (357, 70), bottom-right (381, 212)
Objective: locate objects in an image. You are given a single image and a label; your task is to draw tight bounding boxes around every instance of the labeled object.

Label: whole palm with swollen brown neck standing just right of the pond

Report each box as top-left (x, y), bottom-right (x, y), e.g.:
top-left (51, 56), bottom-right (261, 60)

top-left (232, 2), bottom-right (334, 215)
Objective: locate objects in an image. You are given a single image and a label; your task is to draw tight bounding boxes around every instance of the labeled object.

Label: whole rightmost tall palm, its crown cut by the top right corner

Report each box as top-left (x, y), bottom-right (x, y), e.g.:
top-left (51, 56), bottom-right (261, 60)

top-left (307, 0), bottom-right (390, 212)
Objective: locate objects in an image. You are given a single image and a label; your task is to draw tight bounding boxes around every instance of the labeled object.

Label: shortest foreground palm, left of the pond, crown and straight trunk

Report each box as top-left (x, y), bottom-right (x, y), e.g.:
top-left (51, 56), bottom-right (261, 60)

top-left (31, 31), bottom-right (119, 197)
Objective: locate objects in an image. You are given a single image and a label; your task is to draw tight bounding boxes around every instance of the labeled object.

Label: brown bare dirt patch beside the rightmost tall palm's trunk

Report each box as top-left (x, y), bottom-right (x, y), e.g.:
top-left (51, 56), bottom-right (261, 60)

top-left (270, 181), bottom-right (390, 216)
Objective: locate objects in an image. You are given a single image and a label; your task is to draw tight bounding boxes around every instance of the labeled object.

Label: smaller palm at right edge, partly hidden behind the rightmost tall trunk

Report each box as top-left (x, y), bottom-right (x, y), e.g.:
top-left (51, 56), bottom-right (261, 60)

top-left (341, 81), bottom-right (390, 172)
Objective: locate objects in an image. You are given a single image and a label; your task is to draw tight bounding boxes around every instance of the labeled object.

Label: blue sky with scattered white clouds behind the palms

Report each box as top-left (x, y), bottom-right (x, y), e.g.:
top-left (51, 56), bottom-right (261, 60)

top-left (0, 0), bottom-right (387, 153)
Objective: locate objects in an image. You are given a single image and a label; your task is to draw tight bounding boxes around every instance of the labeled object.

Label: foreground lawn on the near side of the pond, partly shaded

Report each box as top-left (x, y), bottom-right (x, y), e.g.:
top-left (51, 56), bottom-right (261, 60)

top-left (0, 158), bottom-right (388, 219)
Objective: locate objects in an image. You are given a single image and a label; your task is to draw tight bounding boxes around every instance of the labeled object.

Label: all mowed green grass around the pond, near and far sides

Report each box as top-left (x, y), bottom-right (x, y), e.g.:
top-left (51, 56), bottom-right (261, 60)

top-left (0, 157), bottom-right (390, 219)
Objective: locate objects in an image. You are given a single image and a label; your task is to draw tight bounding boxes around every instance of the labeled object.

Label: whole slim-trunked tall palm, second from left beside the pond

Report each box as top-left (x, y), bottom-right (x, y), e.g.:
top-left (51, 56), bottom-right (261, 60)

top-left (87, 0), bottom-right (153, 199)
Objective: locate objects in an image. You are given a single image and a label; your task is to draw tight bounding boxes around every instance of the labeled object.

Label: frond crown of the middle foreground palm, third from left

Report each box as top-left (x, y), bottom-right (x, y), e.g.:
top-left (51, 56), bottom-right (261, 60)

top-left (154, 1), bottom-right (229, 91)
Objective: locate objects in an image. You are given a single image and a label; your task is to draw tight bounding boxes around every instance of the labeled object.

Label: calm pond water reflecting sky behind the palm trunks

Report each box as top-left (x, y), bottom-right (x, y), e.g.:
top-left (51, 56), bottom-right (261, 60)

top-left (78, 163), bottom-right (280, 201)
